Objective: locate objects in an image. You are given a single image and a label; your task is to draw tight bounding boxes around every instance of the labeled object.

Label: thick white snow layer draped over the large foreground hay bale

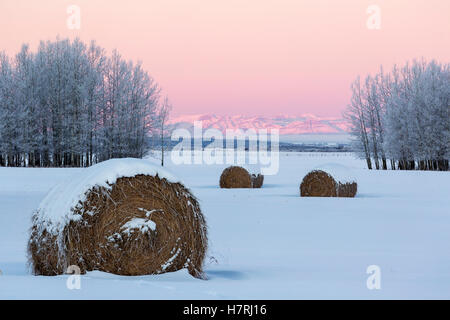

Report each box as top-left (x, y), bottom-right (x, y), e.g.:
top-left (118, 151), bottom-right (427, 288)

top-left (35, 158), bottom-right (181, 234)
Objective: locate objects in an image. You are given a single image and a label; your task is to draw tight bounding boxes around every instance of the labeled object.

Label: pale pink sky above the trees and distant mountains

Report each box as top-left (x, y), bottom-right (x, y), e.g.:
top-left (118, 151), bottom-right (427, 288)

top-left (0, 0), bottom-right (450, 116)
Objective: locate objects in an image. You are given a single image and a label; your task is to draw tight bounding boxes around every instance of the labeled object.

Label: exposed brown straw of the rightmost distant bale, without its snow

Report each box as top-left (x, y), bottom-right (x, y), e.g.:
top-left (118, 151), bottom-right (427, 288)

top-left (300, 170), bottom-right (357, 198)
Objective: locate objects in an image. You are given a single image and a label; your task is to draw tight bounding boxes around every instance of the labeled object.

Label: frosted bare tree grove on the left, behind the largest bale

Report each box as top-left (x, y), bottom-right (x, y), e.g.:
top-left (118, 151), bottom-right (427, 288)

top-left (0, 39), bottom-right (159, 167)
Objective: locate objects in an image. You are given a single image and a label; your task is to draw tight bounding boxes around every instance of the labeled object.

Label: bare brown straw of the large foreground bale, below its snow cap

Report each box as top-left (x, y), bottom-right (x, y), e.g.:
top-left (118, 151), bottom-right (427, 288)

top-left (28, 175), bottom-right (207, 278)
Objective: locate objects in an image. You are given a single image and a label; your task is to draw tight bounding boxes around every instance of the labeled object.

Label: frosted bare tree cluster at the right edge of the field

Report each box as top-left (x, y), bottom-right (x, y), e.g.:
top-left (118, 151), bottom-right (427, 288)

top-left (344, 60), bottom-right (450, 171)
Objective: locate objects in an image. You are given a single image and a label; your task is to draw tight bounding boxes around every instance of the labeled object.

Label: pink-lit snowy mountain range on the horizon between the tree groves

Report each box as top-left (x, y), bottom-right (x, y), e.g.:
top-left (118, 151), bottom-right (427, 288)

top-left (168, 114), bottom-right (348, 135)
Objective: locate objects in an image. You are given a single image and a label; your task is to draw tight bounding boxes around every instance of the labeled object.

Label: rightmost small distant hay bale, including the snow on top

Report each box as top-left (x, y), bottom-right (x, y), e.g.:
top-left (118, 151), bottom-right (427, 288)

top-left (300, 164), bottom-right (357, 198)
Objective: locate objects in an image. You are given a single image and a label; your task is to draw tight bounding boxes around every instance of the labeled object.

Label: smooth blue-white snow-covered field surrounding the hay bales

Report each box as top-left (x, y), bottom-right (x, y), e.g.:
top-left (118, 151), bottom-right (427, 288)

top-left (0, 153), bottom-right (450, 299)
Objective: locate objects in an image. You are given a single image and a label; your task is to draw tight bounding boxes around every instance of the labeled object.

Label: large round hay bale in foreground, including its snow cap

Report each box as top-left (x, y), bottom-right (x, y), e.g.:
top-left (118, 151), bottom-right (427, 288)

top-left (28, 159), bottom-right (207, 278)
